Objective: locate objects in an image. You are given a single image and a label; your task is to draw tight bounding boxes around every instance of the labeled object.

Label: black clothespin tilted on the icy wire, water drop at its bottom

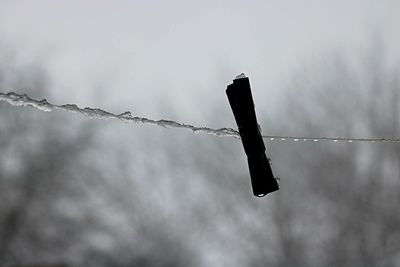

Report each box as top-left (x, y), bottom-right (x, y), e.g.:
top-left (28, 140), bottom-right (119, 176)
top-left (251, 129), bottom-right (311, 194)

top-left (226, 73), bottom-right (279, 197)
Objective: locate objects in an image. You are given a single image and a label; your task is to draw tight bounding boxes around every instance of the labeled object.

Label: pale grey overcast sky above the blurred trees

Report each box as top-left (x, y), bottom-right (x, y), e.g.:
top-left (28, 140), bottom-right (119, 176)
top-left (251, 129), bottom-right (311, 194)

top-left (0, 0), bottom-right (400, 126)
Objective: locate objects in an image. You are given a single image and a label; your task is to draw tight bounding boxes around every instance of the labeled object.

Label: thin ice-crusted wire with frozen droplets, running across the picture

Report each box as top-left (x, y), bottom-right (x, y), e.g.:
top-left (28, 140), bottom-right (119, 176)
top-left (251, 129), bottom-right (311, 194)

top-left (0, 92), bottom-right (400, 143)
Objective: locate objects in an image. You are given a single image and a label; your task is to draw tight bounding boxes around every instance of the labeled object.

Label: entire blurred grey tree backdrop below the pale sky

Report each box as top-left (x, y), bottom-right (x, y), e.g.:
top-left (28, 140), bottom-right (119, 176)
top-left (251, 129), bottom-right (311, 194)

top-left (0, 42), bottom-right (400, 267)
